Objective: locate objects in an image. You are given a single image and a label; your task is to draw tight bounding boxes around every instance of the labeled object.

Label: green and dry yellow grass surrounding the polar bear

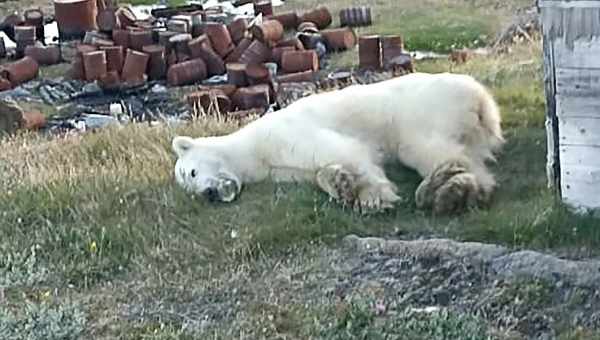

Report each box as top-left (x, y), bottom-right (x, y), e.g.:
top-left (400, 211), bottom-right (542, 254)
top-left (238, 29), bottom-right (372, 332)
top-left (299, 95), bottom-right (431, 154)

top-left (0, 0), bottom-right (600, 339)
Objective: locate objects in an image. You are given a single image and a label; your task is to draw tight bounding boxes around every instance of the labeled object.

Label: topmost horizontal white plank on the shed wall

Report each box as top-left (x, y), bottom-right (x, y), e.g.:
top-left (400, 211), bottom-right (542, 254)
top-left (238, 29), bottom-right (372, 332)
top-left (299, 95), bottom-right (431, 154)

top-left (554, 37), bottom-right (600, 68)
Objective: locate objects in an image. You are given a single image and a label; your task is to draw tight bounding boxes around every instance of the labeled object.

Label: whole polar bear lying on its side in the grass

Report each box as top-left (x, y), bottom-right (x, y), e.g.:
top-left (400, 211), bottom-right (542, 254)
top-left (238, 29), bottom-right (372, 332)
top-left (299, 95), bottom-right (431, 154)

top-left (172, 73), bottom-right (504, 214)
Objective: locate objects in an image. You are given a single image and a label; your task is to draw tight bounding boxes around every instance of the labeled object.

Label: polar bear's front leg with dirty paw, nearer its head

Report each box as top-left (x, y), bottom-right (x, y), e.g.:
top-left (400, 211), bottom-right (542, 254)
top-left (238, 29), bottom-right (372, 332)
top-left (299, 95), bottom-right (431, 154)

top-left (316, 164), bottom-right (400, 213)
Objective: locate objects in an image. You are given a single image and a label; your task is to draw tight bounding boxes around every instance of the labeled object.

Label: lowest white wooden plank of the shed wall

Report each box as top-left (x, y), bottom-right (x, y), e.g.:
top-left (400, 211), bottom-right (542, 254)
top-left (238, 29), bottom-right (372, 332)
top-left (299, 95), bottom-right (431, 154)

top-left (561, 166), bottom-right (600, 209)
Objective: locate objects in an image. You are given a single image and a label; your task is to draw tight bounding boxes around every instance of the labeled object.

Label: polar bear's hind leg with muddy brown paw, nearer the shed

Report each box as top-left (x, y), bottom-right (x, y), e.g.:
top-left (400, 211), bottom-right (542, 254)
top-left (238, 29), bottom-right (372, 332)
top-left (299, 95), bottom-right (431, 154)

top-left (399, 141), bottom-right (496, 215)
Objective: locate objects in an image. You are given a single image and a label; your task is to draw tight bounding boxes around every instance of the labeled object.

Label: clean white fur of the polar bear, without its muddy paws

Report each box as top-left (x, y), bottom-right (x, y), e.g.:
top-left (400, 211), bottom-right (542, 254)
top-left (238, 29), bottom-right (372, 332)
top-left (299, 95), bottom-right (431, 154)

top-left (173, 73), bottom-right (504, 209)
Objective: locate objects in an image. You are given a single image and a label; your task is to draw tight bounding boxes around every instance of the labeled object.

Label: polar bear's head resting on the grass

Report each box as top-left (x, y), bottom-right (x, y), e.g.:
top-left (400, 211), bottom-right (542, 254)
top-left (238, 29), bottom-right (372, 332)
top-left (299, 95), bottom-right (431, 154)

top-left (172, 136), bottom-right (242, 202)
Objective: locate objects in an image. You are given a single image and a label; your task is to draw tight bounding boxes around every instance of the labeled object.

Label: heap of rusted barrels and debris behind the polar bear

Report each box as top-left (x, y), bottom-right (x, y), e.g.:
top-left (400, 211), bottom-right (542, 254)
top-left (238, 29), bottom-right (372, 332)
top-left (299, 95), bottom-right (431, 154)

top-left (0, 0), bottom-right (413, 135)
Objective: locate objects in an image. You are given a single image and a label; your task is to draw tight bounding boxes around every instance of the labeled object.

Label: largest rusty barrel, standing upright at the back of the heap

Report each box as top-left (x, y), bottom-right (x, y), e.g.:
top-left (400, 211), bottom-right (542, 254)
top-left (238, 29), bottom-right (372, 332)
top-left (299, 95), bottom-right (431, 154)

top-left (54, 0), bottom-right (98, 40)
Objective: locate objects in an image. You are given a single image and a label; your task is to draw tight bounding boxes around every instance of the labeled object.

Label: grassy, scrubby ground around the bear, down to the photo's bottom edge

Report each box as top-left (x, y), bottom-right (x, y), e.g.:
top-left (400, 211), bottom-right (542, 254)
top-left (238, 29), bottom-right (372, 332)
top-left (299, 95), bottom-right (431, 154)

top-left (0, 0), bottom-right (600, 339)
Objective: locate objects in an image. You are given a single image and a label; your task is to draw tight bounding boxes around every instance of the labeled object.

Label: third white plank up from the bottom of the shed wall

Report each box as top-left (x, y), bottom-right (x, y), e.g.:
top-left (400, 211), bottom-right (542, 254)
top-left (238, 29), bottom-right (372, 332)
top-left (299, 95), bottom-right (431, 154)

top-left (558, 117), bottom-right (600, 146)
